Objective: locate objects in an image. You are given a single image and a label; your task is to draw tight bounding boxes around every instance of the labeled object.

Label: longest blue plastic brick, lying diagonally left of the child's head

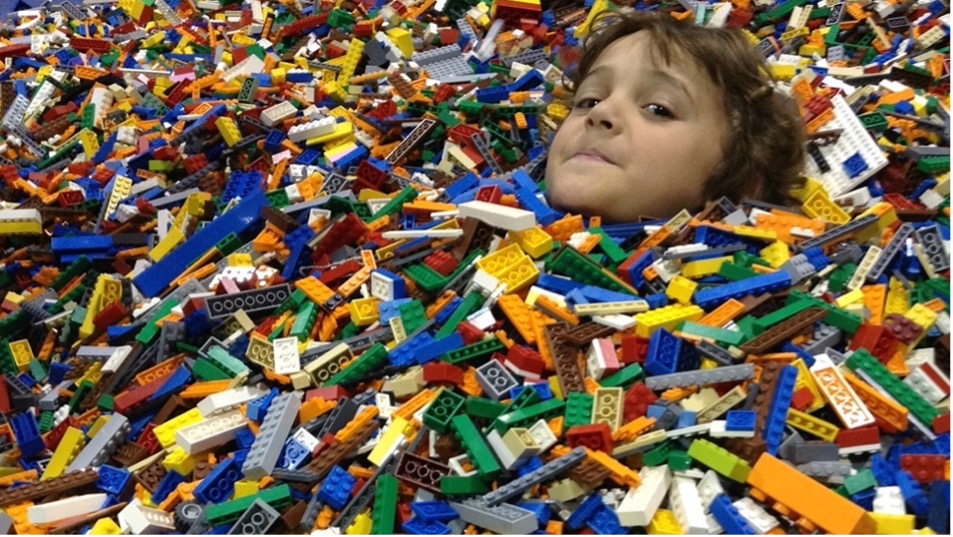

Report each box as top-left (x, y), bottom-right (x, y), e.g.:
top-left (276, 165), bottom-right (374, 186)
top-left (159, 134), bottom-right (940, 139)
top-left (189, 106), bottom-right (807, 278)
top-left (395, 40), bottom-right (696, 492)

top-left (132, 189), bottom-right (268, 298)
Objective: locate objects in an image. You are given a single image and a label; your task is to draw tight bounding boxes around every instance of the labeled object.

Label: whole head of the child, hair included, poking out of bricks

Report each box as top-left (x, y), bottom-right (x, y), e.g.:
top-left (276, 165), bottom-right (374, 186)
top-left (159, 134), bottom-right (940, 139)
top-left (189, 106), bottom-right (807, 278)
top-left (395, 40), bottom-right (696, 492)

top-left (546, 13), bottom-right (805, 221)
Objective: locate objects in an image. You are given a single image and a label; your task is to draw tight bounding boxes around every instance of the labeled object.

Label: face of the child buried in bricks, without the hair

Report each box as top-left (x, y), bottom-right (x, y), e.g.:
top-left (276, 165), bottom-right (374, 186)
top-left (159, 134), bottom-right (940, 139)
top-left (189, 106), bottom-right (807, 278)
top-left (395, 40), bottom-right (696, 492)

top-left (546, 32), bottom-right (728, 221)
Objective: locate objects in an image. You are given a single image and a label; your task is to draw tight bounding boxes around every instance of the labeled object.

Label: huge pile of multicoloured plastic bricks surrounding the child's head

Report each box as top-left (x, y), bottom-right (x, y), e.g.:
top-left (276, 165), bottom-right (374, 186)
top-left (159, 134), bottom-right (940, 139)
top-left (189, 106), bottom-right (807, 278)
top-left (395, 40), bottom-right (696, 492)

top-left (0, 0), bottom-right (950, 534)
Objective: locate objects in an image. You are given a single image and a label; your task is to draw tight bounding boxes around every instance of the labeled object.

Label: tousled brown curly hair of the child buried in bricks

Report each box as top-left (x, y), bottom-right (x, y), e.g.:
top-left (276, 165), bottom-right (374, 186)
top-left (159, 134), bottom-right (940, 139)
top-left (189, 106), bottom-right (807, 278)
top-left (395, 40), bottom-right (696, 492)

top-left (564, 11), bottom-right (806, 205)
